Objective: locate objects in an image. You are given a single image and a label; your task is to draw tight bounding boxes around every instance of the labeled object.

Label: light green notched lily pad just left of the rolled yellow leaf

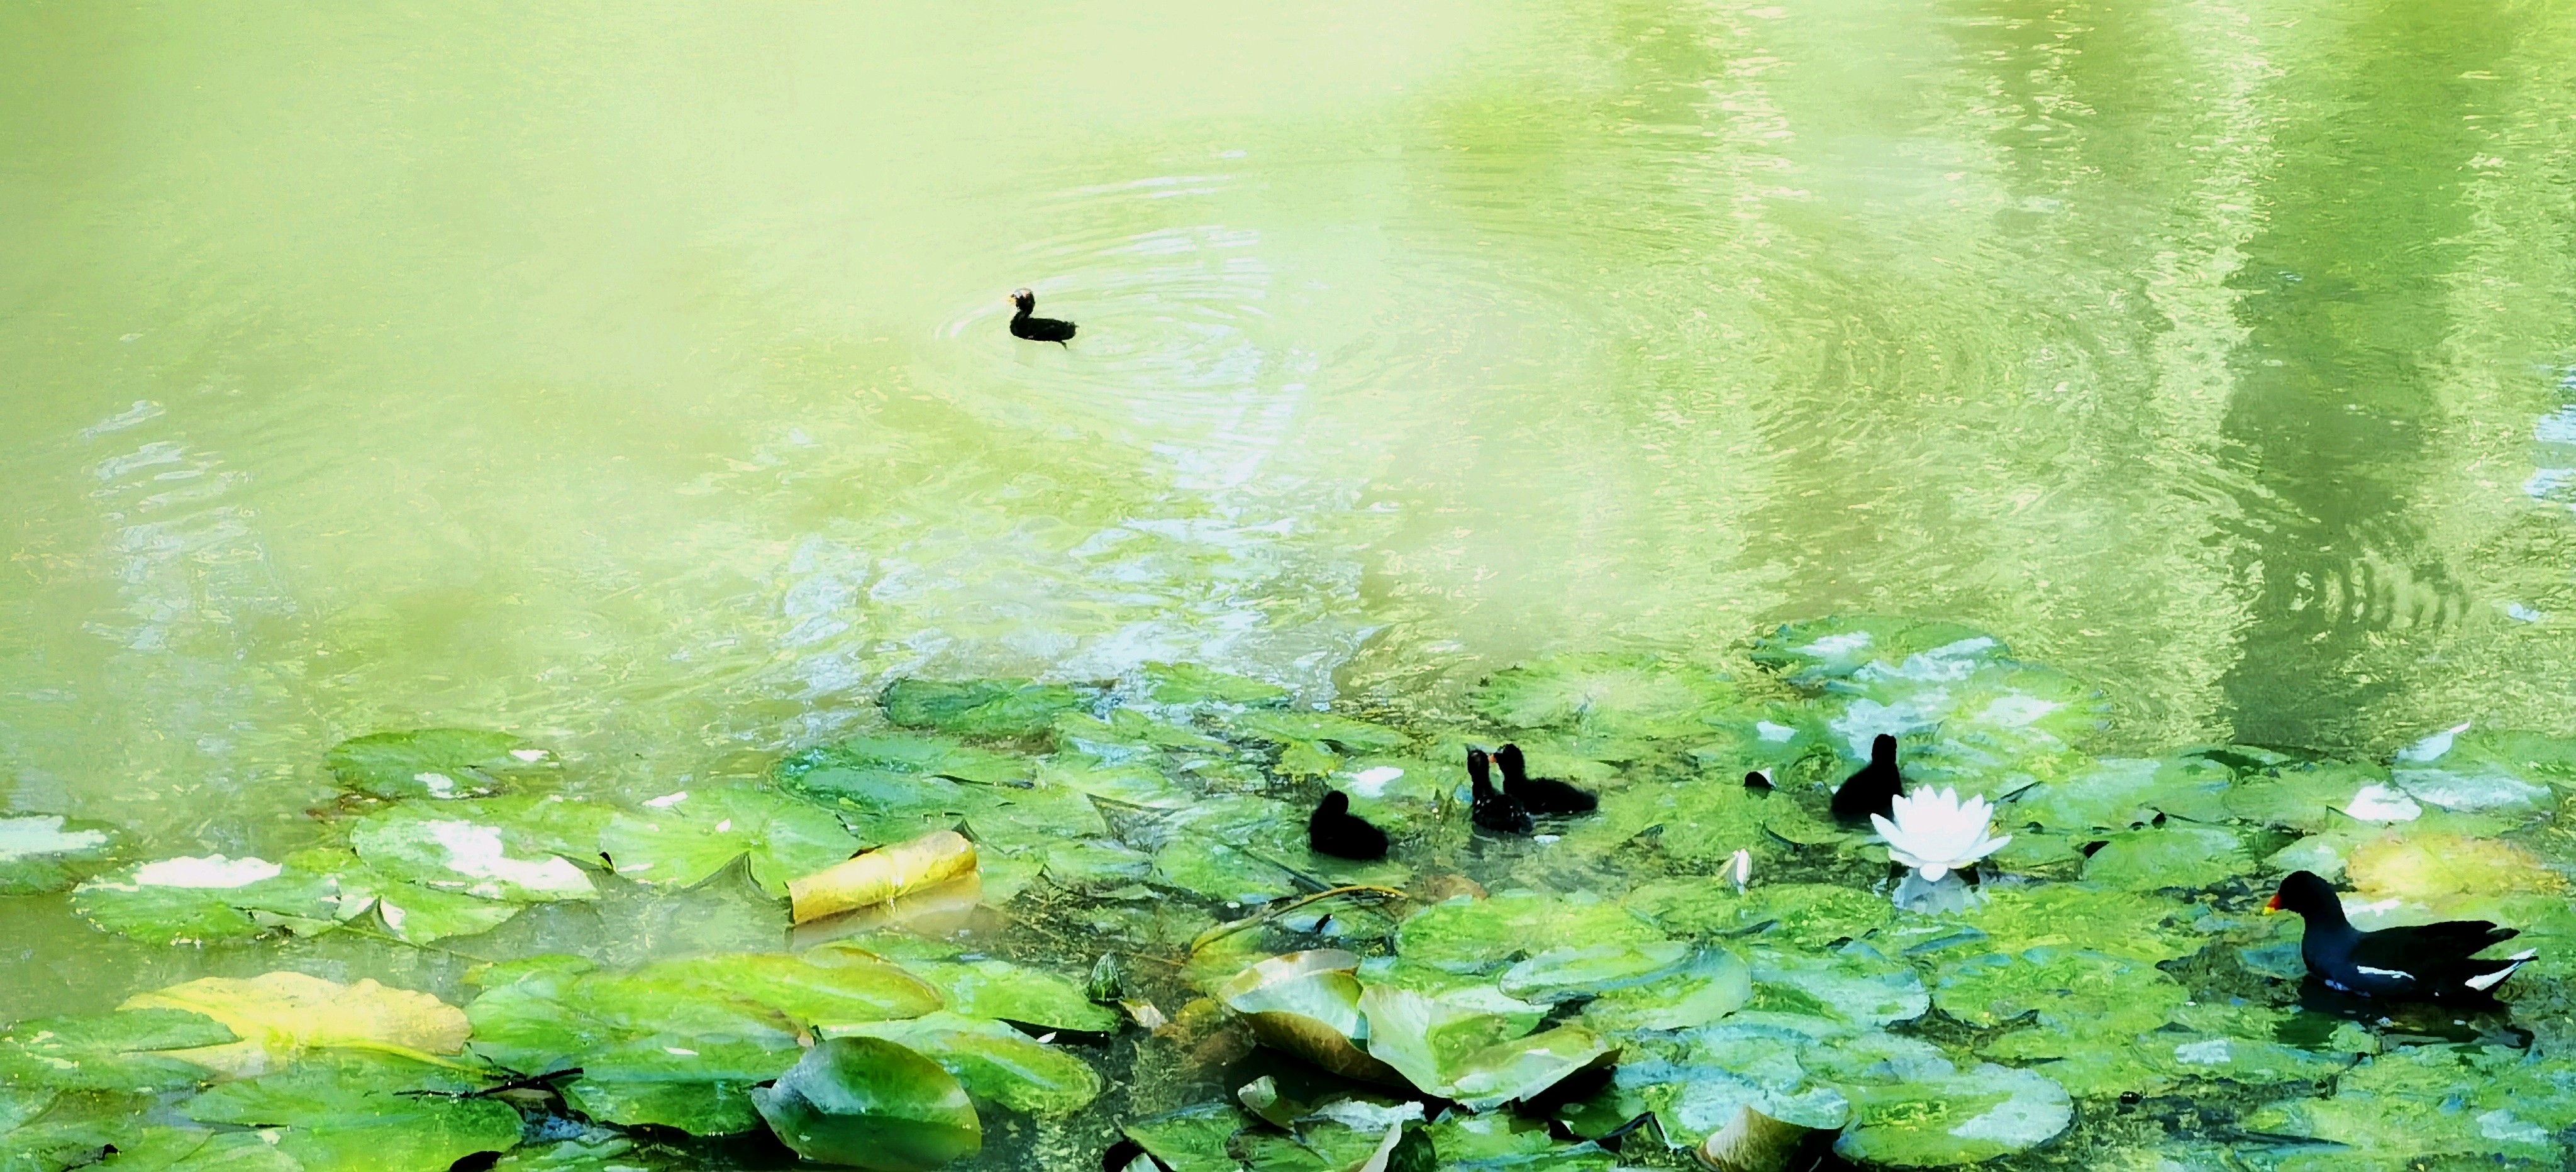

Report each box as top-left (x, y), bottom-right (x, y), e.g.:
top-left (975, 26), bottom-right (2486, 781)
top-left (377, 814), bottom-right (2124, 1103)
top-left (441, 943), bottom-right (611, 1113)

top-left (600, 785), bottom-right (860, 899)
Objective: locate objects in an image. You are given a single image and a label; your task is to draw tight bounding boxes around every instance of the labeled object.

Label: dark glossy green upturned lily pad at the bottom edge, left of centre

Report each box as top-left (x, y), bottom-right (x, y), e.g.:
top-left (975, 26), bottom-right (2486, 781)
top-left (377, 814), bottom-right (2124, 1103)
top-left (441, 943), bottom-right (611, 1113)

top-left (752, 1038), bottom-right (984, 1172)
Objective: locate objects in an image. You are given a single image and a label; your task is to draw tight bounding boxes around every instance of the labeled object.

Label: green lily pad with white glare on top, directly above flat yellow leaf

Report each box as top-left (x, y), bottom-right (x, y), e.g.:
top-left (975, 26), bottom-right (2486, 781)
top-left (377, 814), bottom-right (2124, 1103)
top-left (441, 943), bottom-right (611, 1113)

top-left (72, 855), bottom-right (347, 943)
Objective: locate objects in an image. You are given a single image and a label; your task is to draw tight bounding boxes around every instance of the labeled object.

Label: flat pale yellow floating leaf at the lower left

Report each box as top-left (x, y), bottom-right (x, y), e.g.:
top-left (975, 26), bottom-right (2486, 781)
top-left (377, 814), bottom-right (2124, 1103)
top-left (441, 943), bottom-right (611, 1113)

top-left (118, 971), bottom-right (469, 1076)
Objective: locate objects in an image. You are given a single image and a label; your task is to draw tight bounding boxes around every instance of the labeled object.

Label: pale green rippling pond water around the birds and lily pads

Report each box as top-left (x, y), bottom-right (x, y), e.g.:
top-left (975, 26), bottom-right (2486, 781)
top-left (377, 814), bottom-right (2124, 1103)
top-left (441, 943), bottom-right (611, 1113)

top-left (0, 0), bottom-right (2576, 1167)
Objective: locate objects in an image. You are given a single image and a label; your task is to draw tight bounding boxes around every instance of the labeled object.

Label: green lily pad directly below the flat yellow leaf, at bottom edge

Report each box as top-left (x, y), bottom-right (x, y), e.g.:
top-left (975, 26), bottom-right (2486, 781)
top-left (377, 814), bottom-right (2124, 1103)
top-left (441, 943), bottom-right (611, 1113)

top-left (180, 1054), bottom-right (520, 1172)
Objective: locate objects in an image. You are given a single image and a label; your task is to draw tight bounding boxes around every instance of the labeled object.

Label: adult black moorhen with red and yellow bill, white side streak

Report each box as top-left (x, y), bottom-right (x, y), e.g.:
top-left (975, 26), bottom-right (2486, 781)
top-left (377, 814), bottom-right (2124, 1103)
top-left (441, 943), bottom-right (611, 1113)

top-left (2262, 871), bottom-right (2540, 1002)
